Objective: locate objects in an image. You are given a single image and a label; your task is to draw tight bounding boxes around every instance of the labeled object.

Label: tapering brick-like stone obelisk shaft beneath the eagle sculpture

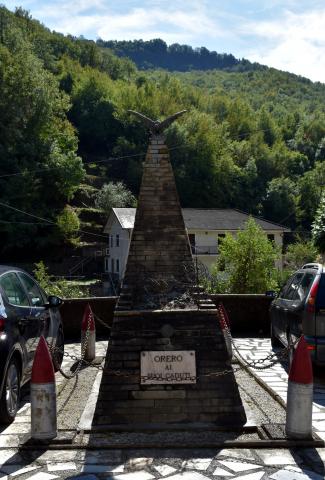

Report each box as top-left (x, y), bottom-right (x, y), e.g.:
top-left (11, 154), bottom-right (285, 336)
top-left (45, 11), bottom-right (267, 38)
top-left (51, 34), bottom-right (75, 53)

top-left (117, 110), bottom-right (195, 310)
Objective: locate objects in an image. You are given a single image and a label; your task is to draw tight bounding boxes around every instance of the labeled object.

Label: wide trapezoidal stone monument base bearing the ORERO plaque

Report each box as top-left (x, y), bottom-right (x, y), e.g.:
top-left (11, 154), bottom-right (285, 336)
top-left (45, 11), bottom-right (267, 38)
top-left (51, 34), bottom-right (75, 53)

top-left (93, 310), bottom-right (246, 429)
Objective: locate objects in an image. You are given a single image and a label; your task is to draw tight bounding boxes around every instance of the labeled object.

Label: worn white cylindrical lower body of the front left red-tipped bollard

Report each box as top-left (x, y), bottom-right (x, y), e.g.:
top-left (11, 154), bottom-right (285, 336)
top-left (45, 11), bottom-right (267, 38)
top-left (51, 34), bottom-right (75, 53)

top-left (30, 383), bottom-right (57, 440)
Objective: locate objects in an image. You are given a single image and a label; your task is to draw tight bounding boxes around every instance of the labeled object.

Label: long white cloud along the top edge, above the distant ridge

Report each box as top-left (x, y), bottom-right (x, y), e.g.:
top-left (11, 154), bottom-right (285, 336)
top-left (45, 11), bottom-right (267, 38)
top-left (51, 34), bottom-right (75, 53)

top-left (29, 0), bottom-right (230, 43)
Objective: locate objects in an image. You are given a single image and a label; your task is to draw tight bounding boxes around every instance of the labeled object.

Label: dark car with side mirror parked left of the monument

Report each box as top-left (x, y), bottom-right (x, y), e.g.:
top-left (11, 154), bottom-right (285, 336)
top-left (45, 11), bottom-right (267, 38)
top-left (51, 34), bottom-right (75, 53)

top-left (0, 266), bottom-right (64, 423)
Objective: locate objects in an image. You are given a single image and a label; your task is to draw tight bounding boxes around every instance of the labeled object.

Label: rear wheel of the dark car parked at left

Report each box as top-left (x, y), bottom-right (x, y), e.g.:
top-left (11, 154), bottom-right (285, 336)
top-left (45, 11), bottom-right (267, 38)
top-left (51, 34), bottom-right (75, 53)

top-left (0, 358), bottom-right (20, 423)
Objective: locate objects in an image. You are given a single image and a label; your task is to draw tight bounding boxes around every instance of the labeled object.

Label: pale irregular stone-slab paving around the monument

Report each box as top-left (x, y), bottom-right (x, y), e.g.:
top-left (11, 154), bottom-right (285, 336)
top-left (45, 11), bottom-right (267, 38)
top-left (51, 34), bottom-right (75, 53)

top-left (0, 339), bottom-right (325, 480)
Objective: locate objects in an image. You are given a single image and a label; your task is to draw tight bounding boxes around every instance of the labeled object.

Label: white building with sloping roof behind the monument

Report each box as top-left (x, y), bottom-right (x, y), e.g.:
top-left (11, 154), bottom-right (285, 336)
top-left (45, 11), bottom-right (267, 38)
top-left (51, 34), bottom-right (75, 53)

top-left (104, 208), bottom-right (290, 280)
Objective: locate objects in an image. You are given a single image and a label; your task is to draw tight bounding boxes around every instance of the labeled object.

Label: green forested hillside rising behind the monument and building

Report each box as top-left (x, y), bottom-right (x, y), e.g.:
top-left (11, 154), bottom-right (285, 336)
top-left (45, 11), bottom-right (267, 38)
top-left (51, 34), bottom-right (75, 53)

top-left (0, 7), bottom-right (325, 262)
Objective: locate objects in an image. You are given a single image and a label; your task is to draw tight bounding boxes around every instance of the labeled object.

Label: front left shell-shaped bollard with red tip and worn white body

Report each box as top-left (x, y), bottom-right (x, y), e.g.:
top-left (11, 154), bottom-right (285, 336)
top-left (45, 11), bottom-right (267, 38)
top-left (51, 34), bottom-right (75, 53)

top-left (31, 335), bottom-right (57, 440)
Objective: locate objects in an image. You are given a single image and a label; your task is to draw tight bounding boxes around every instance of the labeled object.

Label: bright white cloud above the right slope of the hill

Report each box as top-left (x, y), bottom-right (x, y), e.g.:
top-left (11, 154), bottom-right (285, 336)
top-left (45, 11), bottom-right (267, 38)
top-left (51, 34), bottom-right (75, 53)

top-left (243, 8), bottom-right (325, 82)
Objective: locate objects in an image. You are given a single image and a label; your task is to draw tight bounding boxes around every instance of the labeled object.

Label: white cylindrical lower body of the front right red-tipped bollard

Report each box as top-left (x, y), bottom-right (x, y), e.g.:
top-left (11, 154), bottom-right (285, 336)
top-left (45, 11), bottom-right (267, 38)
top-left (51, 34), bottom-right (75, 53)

top-left (286, 381), bottom-right (313, 438)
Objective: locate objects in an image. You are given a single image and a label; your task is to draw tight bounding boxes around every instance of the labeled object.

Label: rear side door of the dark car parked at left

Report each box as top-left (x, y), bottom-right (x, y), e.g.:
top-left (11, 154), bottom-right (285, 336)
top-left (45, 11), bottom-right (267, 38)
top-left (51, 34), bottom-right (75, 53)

top-left (0, 272), bottom-right (33, 382)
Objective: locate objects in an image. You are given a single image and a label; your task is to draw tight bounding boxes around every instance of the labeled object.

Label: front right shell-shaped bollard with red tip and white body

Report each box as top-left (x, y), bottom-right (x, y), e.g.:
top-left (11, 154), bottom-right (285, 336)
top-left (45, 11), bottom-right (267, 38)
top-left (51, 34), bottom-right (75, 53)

top-left (286, 336), bottom-right (313, 438)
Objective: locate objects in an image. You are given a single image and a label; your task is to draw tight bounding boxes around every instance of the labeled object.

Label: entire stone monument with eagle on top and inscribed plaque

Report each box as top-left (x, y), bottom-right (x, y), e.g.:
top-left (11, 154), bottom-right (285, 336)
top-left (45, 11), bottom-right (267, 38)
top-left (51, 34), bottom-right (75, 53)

top-left (93, 111), bottom-right (246, 429)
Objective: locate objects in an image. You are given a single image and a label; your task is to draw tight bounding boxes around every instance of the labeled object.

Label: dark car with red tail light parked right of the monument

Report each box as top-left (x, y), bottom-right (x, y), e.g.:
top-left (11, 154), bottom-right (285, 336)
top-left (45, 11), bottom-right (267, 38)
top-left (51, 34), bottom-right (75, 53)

top-left (270, 263), bottom-right (325, 365)
